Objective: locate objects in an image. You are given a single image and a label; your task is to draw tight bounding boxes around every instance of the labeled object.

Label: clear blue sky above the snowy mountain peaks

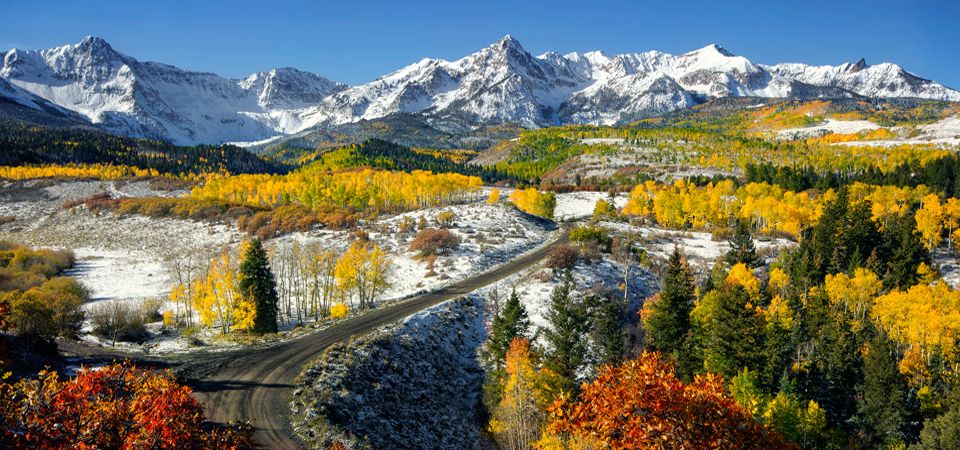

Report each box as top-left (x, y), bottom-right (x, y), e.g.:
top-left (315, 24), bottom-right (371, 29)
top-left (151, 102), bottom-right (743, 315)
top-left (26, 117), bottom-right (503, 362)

top-left (0, 0), bottom-right (960, 88)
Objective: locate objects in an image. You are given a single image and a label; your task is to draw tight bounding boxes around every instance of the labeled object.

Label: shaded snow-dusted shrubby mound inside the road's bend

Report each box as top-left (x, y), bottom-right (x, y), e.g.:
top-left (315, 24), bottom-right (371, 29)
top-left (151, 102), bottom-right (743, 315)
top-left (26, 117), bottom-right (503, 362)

top-left (291, 295), bottom-right (486, 449)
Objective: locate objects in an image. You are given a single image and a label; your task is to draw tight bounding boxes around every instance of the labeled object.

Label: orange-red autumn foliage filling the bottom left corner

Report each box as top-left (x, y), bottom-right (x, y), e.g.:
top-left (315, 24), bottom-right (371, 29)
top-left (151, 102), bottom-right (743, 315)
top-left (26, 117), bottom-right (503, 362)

top-left (0, 364), bottom-right (253, 450)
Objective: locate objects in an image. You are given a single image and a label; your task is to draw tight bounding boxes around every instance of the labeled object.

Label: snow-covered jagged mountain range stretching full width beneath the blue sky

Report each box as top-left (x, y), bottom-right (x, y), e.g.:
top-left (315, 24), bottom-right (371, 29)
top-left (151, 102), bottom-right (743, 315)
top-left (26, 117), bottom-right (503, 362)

top-left (0, 35), bottom-right (960, 144)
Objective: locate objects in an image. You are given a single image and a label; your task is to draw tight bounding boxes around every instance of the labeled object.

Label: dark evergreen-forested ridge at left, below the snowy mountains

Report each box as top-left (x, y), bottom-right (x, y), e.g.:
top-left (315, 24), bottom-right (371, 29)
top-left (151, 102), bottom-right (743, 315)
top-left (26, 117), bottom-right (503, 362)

top-left (0, 120), bottom-right (287, 174)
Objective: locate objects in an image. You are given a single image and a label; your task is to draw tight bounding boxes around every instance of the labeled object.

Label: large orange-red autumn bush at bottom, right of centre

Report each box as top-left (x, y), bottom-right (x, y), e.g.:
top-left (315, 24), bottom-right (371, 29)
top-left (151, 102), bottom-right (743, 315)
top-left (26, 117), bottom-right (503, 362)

top-left (540, 353), bottom-right (795, 450)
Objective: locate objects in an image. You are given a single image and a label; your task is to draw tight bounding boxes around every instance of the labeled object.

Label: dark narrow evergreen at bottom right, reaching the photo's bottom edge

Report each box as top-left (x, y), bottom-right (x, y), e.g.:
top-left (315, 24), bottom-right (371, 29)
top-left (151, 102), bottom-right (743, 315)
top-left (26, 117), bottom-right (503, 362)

top-left (857, 331), bottom-right (910, 448)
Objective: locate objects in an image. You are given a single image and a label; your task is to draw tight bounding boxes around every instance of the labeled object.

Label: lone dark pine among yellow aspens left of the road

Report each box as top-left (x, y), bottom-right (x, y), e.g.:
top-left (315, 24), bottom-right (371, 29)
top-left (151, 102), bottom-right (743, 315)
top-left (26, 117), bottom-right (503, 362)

top-left (240, 238), bottom-right (277, 334)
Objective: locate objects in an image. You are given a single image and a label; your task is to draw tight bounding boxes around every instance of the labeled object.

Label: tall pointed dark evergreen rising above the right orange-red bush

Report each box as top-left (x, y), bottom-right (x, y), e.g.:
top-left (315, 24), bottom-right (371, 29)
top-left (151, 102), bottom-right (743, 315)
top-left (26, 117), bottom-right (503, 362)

top-left (644, 247), bottom-right (695, 356)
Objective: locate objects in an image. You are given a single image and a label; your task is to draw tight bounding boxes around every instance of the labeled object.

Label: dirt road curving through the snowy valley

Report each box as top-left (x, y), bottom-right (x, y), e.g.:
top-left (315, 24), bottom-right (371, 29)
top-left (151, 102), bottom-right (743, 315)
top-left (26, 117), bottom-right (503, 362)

top-left (190, 230), bottom-right (567, 449)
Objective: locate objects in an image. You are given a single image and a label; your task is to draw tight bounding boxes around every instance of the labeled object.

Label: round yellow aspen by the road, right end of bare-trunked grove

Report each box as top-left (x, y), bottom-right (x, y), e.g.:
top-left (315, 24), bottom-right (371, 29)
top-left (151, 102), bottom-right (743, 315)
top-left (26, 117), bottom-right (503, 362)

top-left (334, 241), bottom-right (391, 310)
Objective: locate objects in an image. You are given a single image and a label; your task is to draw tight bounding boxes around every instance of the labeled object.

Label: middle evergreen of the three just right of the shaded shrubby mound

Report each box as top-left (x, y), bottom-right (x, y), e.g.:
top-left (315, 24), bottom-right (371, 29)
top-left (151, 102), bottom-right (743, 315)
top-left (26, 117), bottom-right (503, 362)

top-left (542, 271), bottom-right (589, 392)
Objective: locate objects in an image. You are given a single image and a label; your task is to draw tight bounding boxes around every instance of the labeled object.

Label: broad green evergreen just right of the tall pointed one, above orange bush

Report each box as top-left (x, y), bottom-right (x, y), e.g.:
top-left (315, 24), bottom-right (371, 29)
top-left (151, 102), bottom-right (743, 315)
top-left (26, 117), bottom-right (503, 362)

top-left (703, 284), bottom-right (764, 378)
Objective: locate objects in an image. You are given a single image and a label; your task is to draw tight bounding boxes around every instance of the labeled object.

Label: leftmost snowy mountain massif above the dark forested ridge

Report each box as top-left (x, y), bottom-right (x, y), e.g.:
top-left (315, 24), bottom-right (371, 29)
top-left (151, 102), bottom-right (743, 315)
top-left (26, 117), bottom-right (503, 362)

top-left (0, 37), bottom-right (340, 144)
